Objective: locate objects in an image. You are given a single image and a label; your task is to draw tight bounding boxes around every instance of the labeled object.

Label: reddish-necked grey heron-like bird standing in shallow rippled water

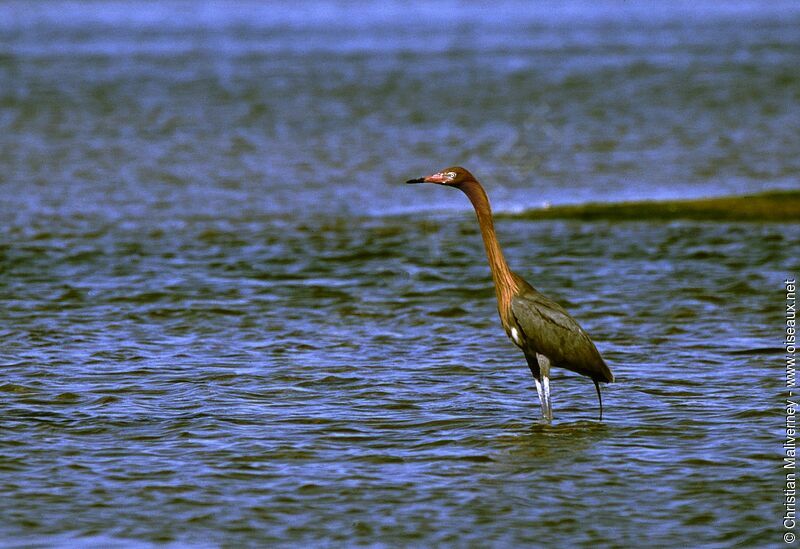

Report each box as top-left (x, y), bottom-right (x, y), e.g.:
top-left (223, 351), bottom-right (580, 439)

top-left (406, 167), bottom-right (614, 421)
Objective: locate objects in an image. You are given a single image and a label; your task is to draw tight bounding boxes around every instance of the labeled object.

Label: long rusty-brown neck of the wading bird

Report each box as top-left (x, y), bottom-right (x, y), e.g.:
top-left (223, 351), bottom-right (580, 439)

top-left (459, 181), bottom-right (518, 310)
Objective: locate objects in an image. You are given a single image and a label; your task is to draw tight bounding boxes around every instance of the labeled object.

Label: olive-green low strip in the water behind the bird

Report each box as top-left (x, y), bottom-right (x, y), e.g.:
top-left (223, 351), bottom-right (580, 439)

top-left (497, 191), bottom-right (800, 223)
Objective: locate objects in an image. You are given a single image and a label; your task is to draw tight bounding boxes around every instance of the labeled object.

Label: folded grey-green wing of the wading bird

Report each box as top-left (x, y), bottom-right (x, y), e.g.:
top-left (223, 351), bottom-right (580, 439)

top-left (511, 289), bottom-right (614, 381)
